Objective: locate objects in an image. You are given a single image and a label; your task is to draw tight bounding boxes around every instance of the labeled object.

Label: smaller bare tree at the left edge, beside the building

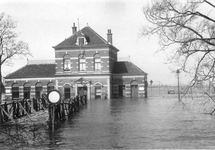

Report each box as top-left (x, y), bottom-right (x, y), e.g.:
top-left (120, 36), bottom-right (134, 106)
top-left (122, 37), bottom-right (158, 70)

top-left (0, 13), bottom-right (31, 101)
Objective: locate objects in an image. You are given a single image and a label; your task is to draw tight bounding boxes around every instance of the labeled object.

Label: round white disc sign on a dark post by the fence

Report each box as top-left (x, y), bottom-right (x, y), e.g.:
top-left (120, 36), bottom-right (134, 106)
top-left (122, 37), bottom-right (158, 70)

top-left (47, 90), bottom-right (61, 132)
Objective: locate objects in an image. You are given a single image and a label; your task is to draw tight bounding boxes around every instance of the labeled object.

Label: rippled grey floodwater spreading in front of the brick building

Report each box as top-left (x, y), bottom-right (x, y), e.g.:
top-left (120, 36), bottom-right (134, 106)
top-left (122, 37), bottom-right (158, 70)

top-left (2, 97), bottom-right (215, 149)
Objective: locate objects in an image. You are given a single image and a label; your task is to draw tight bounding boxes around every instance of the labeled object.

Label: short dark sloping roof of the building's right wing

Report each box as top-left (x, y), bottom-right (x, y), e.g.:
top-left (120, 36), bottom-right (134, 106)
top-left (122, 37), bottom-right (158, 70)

top-left (113, 61), bottom-right (147, 75)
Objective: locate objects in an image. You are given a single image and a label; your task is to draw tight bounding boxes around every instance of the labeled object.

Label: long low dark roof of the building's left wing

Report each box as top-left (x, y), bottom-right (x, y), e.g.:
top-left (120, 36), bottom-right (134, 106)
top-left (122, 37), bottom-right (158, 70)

top-left (5, 64), bottom-right (55, 79)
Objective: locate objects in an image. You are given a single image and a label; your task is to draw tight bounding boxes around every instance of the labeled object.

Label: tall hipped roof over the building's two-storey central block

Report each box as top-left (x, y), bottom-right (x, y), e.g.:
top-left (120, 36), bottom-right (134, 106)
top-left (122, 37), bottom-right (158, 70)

top-left (54, 26), bottom-right (110, 49)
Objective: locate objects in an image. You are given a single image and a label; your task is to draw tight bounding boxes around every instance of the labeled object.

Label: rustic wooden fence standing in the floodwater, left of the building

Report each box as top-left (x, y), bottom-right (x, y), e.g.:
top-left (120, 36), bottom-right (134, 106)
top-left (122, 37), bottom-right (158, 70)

top-left (0, 96), bottom-right (87, 125)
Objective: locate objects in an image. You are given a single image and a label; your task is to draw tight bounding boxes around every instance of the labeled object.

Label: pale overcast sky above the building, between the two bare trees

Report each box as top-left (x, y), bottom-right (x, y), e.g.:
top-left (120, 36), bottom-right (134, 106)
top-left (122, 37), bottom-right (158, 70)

top-left (0, 0), bottom-right (183, 84)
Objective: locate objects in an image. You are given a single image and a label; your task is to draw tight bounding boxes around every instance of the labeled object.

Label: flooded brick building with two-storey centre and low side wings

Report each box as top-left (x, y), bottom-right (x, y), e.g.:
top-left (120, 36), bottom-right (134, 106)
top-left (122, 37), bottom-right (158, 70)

top-left (5, 24), bottom-right (147, 99)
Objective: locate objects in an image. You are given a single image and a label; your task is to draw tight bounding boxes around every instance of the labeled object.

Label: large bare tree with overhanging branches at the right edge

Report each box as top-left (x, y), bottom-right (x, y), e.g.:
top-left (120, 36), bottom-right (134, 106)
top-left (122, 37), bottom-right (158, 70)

top-left (142, 0), bottom-right (215, 87)
